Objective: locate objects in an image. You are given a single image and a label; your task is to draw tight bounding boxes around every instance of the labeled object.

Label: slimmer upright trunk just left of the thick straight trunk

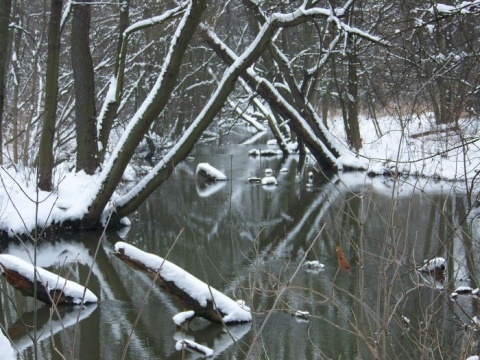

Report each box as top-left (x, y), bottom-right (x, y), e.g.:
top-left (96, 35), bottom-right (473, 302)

top-left (38, 0), bottom-right (63, 191)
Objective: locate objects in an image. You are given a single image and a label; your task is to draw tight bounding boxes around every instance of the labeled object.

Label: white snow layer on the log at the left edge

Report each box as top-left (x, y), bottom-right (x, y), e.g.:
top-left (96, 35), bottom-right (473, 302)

top-left (0, 254), bottom-right (98, 304)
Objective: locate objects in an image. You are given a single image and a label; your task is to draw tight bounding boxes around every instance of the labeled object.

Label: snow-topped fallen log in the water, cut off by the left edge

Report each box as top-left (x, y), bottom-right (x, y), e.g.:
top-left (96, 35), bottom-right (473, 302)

top-left (0, 254), bottom-right (98, 305)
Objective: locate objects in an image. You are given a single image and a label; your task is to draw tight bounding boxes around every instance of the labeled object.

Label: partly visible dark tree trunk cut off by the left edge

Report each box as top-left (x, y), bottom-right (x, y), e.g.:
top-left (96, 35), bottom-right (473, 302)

top-left (0, 0), bottom-right (12, 165)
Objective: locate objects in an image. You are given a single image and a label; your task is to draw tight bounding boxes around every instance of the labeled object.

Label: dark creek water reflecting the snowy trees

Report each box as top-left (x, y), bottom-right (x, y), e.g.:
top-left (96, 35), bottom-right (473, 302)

top-left (0, 128), bottom-right (480, 360)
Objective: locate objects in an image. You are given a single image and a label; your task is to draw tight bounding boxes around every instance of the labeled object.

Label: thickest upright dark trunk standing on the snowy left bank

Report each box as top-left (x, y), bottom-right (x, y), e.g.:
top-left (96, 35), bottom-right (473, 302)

top-left (71, 0), bottom-right (98, 174)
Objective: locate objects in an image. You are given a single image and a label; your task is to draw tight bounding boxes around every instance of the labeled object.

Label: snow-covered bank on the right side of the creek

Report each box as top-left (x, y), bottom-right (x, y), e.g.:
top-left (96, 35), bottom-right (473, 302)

top-left (329, 114), bottom-right (480, 180)
